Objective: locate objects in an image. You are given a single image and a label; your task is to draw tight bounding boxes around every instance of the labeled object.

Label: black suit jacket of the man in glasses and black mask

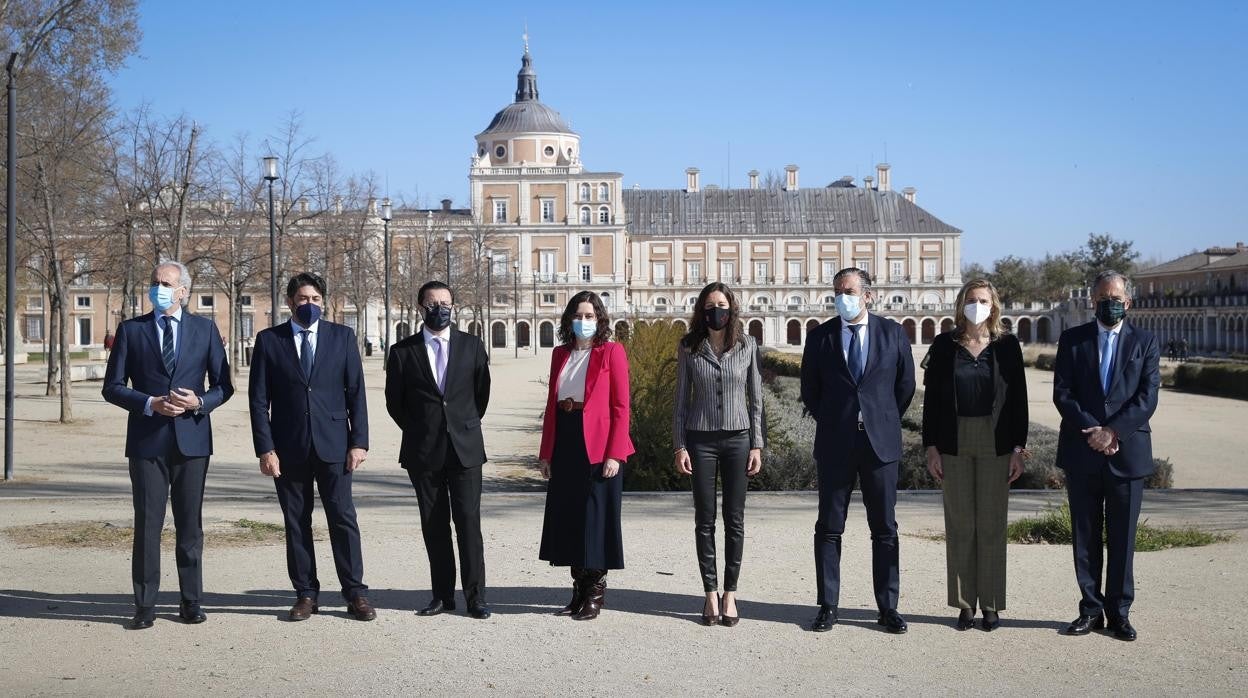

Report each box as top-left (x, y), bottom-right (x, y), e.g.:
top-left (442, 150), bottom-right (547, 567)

top-left (386, 327), bottom-right (489, 471)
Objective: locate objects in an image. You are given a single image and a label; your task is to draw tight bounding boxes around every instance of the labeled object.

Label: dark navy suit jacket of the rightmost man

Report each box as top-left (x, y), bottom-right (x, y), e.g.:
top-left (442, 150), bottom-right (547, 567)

top-left (1053, 320), bottom-right (1162, 478)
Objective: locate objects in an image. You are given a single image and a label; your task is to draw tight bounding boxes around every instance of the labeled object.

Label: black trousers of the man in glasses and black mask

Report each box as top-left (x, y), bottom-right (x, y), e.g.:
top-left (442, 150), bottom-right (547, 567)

top-left (407, 448), bottom-right (485, 606)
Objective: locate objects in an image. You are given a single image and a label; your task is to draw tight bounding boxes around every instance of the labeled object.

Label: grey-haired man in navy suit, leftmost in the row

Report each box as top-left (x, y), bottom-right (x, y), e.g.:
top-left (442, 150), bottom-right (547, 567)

top-left (102, 261), bottom-right (233, 629)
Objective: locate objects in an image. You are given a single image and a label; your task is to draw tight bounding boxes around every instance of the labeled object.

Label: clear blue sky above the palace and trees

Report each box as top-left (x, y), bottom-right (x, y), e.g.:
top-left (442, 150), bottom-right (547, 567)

top-left (114, 0), bottom-right (1248, 263)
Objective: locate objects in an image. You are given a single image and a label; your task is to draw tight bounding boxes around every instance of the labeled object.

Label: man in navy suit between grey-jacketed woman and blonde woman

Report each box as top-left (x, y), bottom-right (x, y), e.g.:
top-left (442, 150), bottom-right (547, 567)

top-left (801, 267), bottom-right (915, 633)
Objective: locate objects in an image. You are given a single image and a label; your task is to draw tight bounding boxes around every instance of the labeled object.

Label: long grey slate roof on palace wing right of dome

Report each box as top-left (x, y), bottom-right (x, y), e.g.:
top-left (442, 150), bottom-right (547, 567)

top-left (624, 187), bottom-right (962, 236)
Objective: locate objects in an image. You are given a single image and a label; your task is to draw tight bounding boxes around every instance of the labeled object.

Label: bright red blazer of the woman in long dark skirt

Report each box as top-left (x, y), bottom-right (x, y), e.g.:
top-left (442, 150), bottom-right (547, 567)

top-left (538, 342), bottom-right (634, 465)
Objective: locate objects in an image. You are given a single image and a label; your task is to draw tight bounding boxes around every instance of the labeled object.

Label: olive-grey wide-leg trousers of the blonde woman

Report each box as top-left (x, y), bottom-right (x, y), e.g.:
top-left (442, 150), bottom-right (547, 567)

top-left (941, 417), bottom-right (1010, 612)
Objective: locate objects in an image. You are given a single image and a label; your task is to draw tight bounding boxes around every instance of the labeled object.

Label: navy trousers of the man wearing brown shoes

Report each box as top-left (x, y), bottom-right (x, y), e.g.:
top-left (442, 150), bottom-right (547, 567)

top-left (273, 456), bottom-right (368, 601)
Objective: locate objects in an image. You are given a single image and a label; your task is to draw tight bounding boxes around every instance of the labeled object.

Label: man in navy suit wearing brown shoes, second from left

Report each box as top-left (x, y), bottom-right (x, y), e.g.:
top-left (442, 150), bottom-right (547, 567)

top-left (248, 273), bottom-right (377, 621)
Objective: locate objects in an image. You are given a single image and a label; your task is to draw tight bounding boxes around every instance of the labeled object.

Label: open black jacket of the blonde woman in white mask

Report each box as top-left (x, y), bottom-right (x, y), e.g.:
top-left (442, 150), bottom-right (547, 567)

top-left (924, 331), bottom-right (1028, 456)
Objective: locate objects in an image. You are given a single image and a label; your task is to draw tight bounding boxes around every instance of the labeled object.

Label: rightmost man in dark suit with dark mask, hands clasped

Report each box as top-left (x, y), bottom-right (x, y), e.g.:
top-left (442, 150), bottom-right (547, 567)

top-left (1053, 271), bottom-right (1162, 641)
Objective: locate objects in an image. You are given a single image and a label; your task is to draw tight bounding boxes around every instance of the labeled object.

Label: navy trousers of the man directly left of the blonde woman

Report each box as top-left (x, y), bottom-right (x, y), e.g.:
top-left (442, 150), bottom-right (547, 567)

top-left (815, 431), bottom-right (901, 611)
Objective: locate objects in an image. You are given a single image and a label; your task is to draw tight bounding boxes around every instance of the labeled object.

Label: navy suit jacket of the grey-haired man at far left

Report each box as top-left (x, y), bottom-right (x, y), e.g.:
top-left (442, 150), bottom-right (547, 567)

top-left (101, 310), bottom-right (233, 458)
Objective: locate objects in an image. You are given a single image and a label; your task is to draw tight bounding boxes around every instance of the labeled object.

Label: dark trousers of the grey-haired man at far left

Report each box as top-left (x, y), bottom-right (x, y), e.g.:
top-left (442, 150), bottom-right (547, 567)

top-left (130, 453), bottom-right (208, 608)
